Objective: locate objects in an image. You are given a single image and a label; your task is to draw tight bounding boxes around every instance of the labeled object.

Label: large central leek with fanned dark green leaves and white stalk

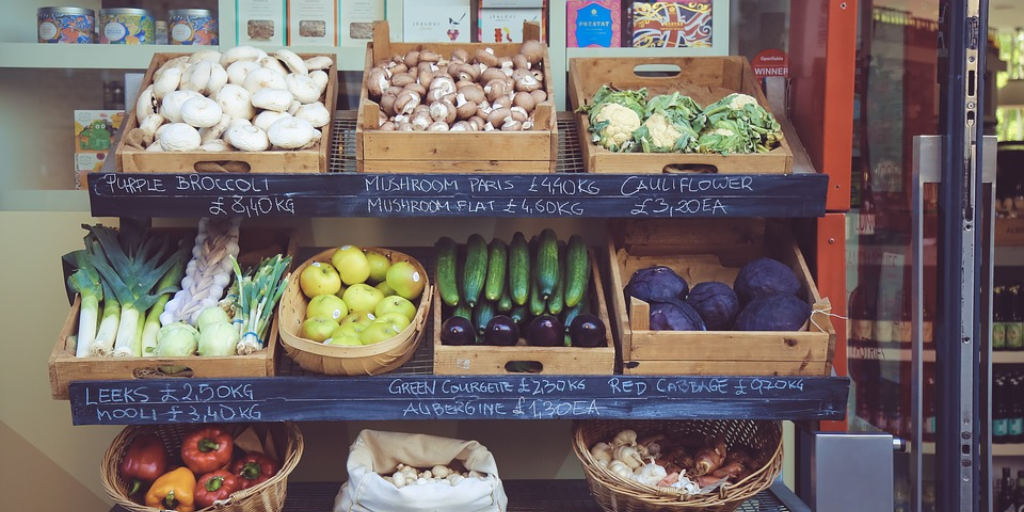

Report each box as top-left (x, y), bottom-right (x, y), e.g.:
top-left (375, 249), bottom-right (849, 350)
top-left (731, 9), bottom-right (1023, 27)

top-left (85, 225), bottom-right (185, 356)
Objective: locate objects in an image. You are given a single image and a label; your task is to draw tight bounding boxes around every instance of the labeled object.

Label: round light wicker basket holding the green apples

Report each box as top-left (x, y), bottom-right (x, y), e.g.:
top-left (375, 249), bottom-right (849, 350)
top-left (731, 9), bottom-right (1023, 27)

top-left (278, 247), bottom-right (433, 376)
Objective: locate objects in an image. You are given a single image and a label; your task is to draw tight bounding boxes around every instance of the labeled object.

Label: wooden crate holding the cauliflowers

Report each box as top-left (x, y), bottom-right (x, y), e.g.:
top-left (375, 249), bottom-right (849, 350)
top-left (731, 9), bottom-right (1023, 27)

top-left (568, 56), bottom-right (793, 174)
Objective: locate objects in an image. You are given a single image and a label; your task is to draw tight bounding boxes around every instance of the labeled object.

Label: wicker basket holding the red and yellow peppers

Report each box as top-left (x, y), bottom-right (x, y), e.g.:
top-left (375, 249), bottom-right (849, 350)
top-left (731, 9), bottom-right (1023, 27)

top-left (99, 422), bottom-right (303, 512)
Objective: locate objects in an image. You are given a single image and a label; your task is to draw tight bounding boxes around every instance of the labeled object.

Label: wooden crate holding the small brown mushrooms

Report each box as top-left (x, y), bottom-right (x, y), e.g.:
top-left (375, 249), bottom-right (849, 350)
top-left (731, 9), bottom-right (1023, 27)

top-left (356, 22), bottom-right (558, 173)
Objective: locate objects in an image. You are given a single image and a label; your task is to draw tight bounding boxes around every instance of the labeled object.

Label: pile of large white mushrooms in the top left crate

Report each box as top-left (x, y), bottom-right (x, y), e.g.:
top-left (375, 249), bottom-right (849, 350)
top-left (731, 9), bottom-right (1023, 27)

top-left (126, 46), bottom-right (334, 152)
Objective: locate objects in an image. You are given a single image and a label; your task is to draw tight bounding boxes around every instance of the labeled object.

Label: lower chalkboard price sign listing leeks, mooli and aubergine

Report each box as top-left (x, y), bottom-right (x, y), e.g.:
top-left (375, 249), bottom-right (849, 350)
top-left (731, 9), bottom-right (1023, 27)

top-left (70, 376), bottom-right (849, 425)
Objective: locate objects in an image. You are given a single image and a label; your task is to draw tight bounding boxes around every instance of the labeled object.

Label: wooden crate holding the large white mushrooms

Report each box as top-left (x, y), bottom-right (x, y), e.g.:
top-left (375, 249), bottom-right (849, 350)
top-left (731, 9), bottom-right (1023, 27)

top-left (115, 53), bottom-right (338, 174)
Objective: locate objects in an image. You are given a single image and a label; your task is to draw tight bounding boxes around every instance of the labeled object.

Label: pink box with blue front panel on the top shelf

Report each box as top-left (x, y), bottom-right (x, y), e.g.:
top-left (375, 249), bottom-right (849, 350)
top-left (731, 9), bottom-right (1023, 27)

top-left (565, 0), bottom-right (623, 48)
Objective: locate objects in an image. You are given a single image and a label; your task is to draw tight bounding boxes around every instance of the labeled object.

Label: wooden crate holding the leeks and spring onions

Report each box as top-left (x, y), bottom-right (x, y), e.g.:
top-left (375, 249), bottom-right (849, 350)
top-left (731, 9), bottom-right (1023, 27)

top-left (49, 228), bottom-right (295, 399)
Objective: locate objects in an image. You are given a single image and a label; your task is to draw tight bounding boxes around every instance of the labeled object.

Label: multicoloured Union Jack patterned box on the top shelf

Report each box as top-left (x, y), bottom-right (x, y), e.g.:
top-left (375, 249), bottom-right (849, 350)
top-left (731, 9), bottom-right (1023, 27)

top-left (630, 0), bottom-right (713, 48)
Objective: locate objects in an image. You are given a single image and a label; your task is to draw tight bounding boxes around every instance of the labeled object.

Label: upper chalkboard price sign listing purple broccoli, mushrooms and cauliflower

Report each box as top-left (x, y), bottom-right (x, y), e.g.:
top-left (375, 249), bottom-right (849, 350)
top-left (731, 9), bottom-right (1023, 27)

top-left (83, 173), bottom-right (828, 218)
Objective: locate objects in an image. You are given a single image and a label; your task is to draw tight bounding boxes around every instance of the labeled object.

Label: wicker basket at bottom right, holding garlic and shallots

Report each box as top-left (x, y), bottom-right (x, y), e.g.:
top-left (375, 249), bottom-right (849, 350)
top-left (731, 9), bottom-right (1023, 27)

top-left (572, 420), bottom-right (782, 512)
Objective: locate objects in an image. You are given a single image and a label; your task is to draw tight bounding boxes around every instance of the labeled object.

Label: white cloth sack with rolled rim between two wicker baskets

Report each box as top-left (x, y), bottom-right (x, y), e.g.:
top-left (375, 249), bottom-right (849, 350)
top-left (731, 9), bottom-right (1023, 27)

top-left (334, 430), bottom-right (508, 512)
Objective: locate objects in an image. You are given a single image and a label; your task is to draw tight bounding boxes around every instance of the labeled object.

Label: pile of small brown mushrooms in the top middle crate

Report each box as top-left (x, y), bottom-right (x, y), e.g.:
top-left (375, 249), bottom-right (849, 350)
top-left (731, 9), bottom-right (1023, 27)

top-left (366, 41), bottom-right (548, 131)
